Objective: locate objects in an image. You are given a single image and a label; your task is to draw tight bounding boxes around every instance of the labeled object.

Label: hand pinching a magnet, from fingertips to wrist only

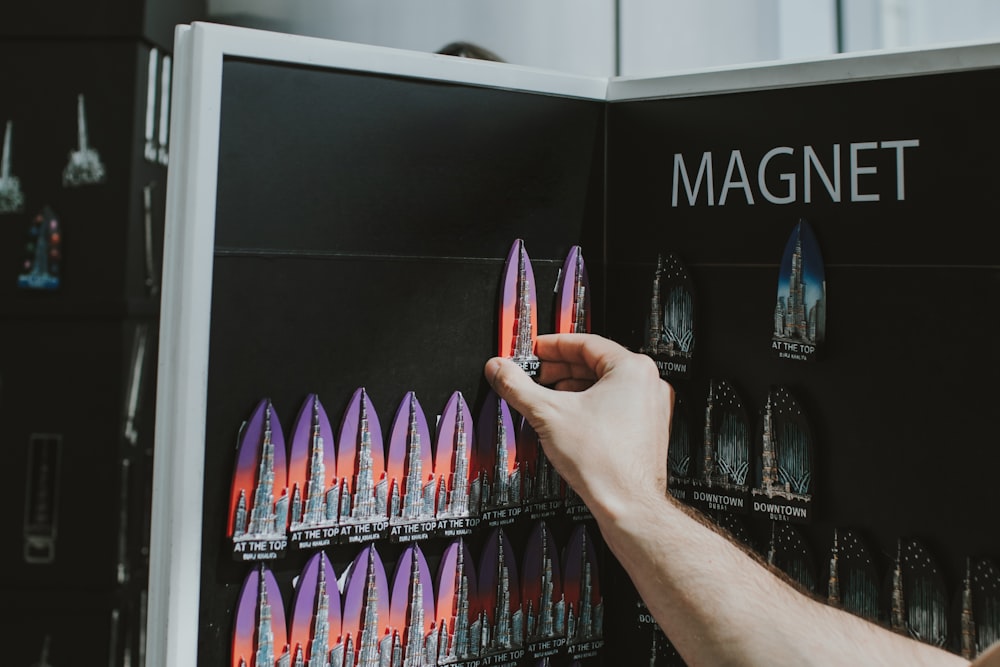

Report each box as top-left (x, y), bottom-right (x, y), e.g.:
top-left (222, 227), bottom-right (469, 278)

top-left (484, 334), bottom-right (674, 519)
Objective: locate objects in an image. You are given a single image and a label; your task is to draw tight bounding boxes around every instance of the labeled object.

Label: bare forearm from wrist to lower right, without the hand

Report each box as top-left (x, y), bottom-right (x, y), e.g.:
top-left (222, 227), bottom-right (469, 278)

top-left (592, 496), bottom-right (968, 667)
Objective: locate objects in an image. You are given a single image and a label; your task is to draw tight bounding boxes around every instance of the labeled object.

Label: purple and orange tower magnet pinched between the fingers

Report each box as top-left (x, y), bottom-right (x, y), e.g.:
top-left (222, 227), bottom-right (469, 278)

top-left (499, 239), bottom-right (540, 377)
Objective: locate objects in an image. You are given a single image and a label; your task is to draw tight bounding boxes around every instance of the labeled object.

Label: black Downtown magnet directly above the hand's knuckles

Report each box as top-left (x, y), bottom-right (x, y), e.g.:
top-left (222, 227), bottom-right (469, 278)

top-left (639, 254), bottom-right (695, 380)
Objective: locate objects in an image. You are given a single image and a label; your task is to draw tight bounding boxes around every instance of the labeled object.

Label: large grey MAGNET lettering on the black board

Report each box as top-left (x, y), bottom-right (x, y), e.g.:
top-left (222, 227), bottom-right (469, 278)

top-left (670, 139), bottom-right (920, 207)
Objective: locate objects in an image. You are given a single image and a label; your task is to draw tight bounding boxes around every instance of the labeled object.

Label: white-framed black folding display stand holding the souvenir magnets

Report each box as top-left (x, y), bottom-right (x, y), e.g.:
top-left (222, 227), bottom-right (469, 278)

top-left (148, 24), bottom-right (1000, 667)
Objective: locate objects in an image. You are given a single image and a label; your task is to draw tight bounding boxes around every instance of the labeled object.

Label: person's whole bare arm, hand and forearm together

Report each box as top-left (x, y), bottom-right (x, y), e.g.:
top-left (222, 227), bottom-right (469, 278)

top-left (484, 334), bottom-right (1000, 667)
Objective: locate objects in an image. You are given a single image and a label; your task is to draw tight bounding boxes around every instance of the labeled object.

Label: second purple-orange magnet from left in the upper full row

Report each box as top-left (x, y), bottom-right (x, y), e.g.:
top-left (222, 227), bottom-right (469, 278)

top-left (288, 394), bottom-right (340, 549)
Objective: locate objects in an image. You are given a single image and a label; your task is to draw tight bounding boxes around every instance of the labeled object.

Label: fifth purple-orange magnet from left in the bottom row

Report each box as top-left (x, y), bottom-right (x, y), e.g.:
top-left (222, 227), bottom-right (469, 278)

top-left (436, 538), bottom-right (483, 667)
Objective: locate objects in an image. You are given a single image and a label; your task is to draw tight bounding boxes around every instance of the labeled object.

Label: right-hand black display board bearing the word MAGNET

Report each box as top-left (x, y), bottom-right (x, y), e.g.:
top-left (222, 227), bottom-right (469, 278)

top-left (607, 64), bottom-right (1000, 659)
